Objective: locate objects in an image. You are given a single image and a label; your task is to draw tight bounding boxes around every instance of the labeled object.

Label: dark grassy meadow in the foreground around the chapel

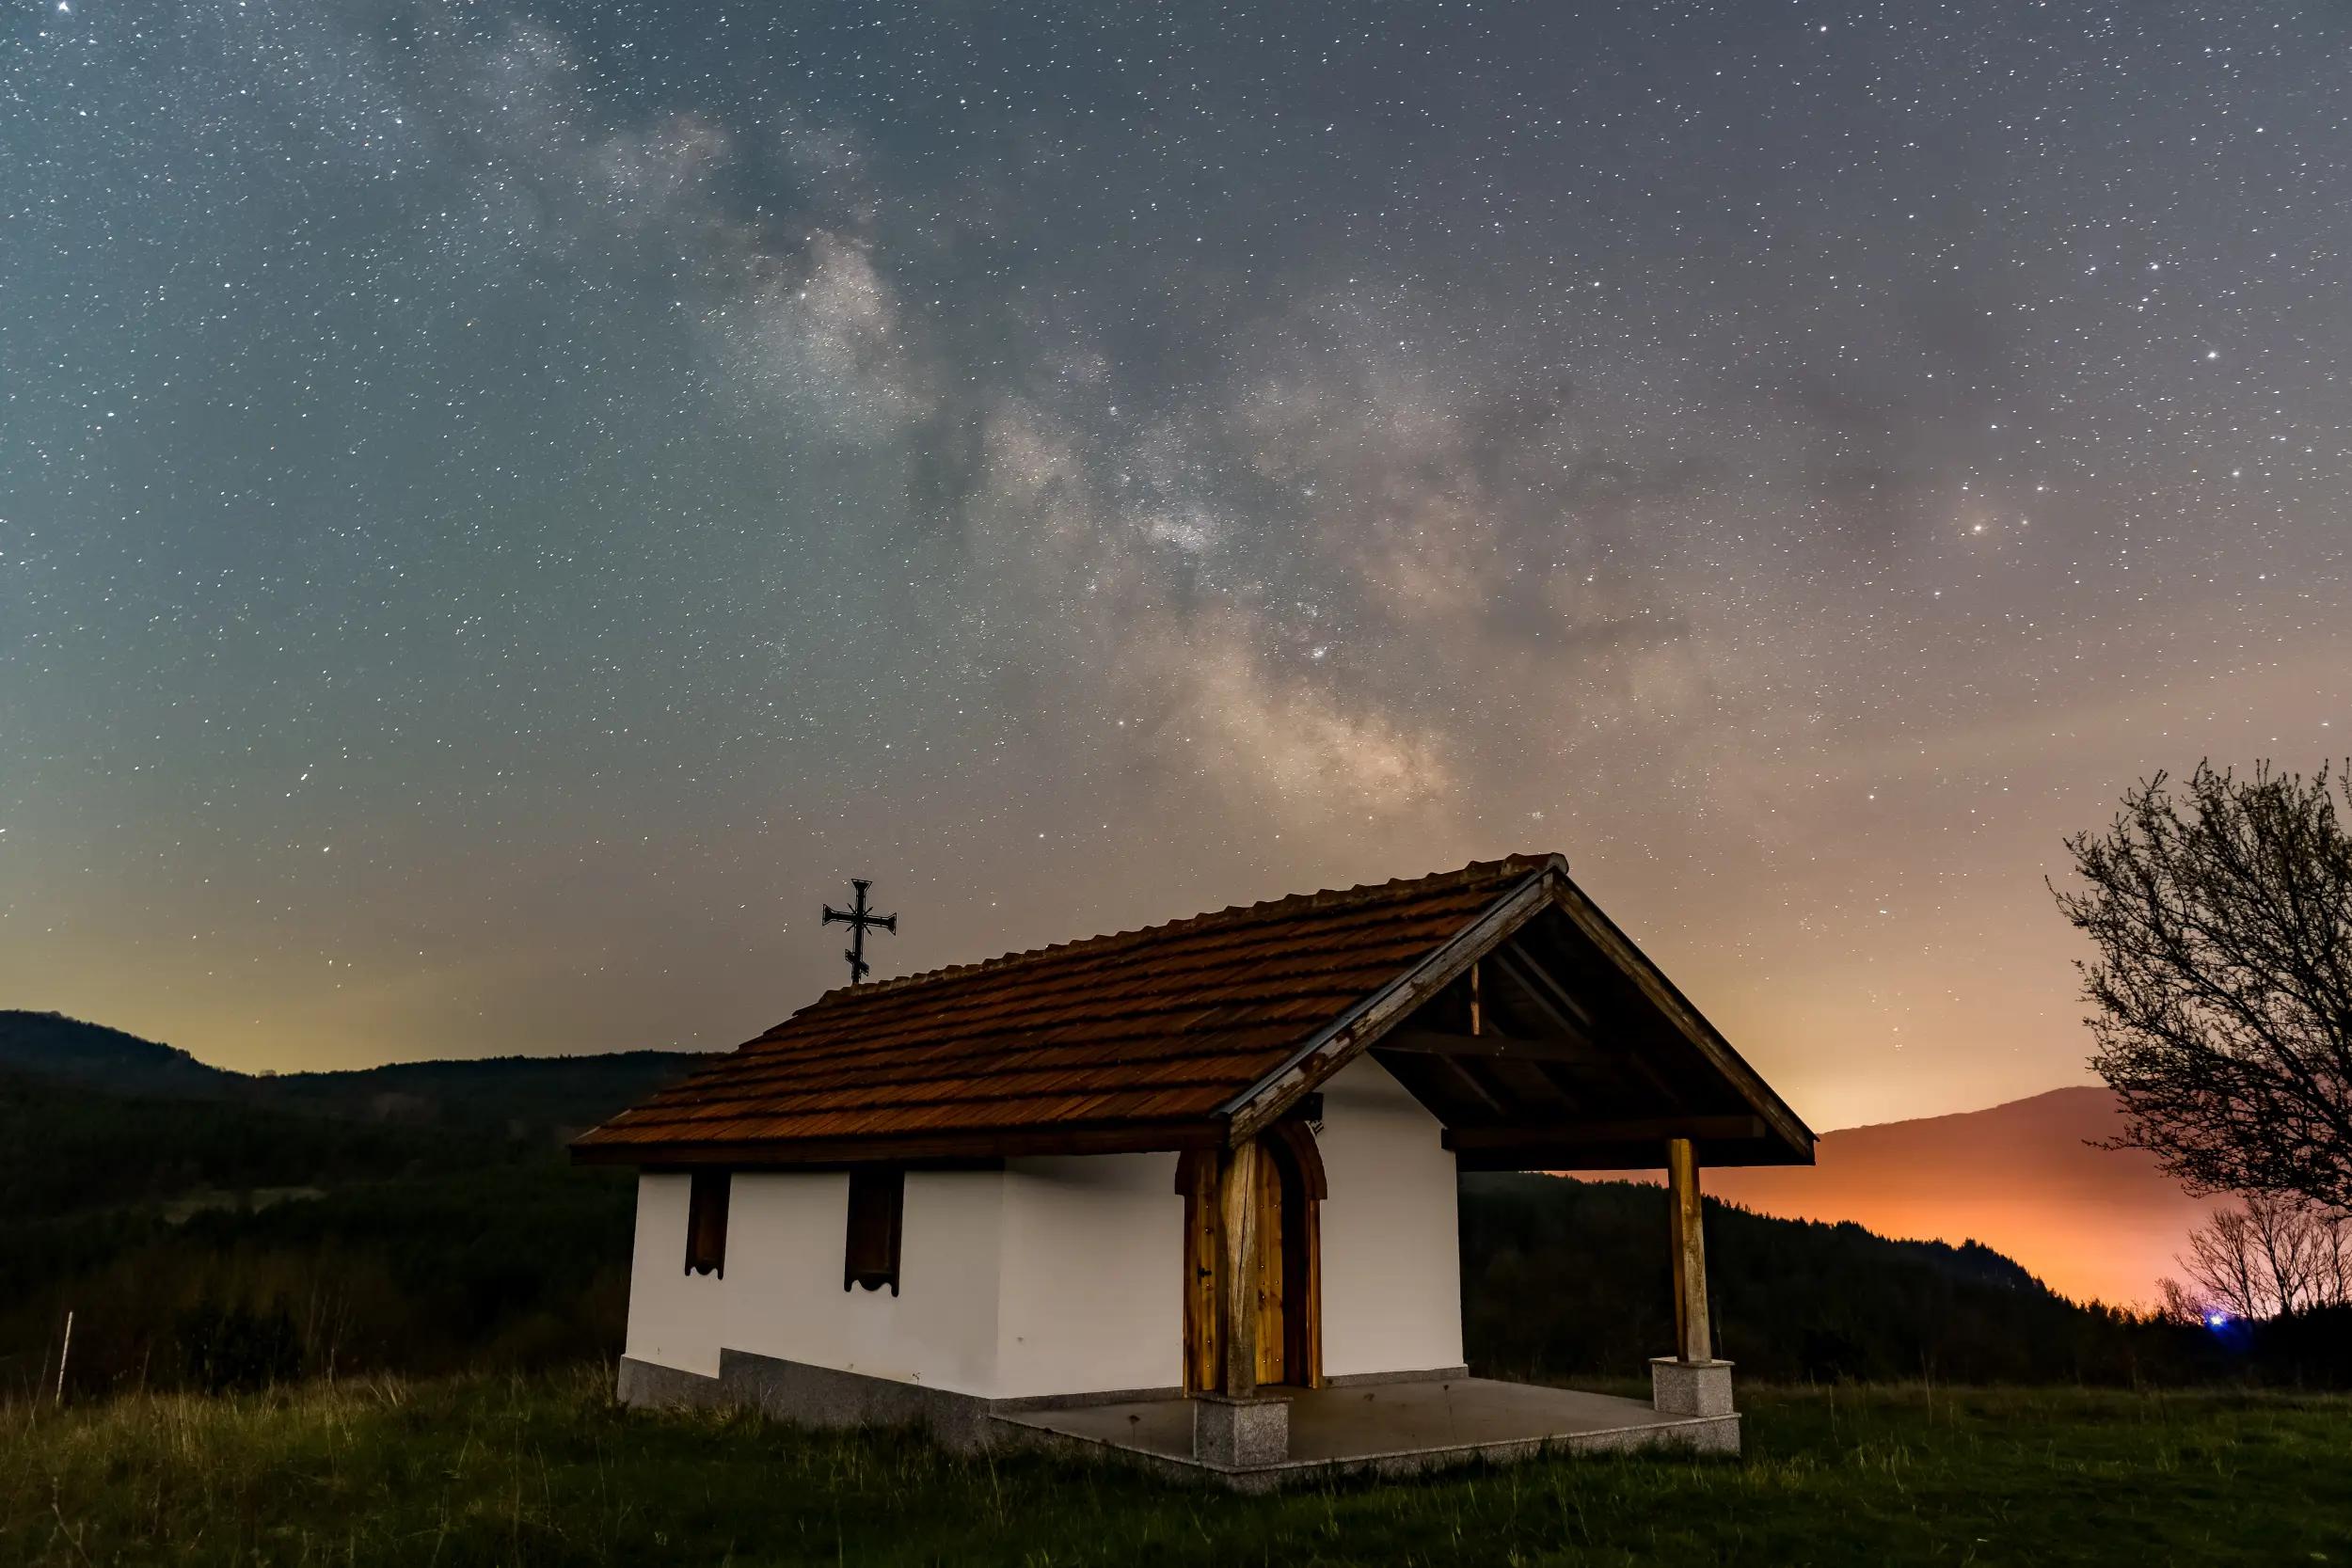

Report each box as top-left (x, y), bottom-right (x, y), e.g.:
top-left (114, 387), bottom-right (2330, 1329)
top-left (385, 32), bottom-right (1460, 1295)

top-left (0, 1370), bottom-right (2352, 1568)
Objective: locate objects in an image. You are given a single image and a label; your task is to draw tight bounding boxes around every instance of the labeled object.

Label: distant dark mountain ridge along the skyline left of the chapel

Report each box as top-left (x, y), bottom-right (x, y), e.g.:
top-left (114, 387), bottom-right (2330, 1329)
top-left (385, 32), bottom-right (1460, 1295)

top-left (0, 1008), bottom-right (710, 1140)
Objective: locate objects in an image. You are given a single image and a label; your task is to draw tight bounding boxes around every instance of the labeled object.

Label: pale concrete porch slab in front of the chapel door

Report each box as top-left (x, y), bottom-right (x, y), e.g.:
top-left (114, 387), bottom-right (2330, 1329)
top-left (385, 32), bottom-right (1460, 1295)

top-left (988, 1378), bottom-right (1740, 1491)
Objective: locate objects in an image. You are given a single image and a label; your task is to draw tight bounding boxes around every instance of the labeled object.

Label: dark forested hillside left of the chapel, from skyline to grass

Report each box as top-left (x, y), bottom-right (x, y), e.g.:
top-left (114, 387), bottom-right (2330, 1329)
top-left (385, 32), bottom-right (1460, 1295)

top-left (0, 1029), bottom-right (649, 1392)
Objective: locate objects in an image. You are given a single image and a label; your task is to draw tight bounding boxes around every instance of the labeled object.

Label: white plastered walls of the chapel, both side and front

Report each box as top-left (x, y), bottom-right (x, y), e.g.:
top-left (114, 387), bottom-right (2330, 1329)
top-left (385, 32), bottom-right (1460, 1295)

top-left (628, 1058), bottom-right (1463, 1399)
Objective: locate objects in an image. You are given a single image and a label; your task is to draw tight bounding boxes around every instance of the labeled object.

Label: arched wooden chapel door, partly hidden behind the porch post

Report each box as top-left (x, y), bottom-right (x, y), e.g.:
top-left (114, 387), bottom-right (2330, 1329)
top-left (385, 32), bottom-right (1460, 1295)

top-left (1176, 1124), bottom-right (1327, 1394)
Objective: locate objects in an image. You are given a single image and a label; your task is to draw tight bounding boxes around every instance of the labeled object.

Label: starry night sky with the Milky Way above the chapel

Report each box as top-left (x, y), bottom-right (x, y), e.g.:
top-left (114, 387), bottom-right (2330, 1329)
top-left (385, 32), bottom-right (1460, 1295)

top-left (0, 0), bottom-right (2352, 1126)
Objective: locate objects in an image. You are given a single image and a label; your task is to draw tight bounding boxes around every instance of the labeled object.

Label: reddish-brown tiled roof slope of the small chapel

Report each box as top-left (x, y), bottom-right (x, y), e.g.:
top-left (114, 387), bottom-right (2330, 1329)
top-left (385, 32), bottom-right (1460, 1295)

top-left (574, 856), bottom-right (1555, 1162)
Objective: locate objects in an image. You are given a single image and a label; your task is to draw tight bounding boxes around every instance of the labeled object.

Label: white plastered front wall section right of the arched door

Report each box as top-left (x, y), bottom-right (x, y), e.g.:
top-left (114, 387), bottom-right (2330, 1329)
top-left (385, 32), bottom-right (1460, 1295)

top-left (1317, 1055), bottom-right (1463, 1378)
